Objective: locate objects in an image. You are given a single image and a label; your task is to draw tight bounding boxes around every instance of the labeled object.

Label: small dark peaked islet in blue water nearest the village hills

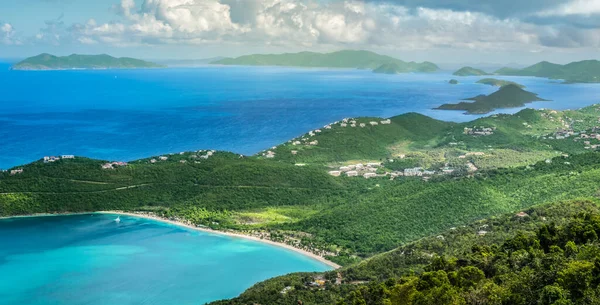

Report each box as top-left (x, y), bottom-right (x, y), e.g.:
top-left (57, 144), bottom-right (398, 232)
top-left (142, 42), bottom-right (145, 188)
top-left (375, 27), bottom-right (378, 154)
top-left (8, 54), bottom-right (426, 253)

top-left (435, 84), bottom-right (545, 114)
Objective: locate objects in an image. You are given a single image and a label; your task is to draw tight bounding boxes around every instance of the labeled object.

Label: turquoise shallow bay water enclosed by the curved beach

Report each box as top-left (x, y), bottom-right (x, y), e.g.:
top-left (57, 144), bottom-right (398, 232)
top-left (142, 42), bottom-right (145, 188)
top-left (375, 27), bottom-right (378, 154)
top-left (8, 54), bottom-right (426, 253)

top-left (0, 214), bottom-right (330, 305)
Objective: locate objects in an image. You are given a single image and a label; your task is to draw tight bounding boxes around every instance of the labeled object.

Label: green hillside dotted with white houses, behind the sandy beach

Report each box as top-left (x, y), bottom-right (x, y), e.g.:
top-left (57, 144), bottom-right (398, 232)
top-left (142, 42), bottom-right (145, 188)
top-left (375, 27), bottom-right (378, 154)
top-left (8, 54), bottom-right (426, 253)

top-left (0, 106), bottom-right (600, 264)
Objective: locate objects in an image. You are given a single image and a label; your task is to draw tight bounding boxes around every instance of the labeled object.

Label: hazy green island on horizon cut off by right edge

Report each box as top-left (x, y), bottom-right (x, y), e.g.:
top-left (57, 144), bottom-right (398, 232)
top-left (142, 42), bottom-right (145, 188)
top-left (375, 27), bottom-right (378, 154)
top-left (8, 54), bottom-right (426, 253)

top-left (495, 60), bottom-right (600, 83)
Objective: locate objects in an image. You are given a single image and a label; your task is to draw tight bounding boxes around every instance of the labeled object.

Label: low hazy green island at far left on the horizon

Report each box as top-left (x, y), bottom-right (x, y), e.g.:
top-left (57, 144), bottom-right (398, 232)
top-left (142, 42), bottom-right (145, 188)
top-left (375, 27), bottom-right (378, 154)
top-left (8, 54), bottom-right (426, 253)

top-left (11, 53), bottom-right (165, 70)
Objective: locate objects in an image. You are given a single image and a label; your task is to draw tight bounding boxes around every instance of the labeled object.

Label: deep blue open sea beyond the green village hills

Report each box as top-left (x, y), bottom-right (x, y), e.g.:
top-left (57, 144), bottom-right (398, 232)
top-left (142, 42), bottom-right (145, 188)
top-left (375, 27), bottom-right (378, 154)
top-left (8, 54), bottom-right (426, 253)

top-left (0, 63), bottom-right (600, 168)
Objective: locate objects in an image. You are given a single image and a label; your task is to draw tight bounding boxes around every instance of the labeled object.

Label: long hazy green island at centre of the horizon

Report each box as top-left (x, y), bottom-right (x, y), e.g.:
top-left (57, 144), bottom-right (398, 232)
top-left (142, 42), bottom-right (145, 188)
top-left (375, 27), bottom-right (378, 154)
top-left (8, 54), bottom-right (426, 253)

top-left (212, 50), bottom-right (439, 74)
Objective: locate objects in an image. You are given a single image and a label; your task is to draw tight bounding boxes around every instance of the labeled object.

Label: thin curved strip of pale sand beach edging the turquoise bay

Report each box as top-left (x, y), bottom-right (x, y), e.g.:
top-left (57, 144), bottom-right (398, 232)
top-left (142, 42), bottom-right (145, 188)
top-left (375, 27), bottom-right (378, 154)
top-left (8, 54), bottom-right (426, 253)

top-left (0, 211), bottom-right (341, 269)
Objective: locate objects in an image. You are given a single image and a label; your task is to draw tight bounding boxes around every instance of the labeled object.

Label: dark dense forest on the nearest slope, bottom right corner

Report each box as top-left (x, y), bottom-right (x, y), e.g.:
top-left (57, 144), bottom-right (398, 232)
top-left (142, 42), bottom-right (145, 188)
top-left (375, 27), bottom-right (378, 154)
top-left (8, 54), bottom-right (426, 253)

top-left (214, 200), bottom-right (600, 305)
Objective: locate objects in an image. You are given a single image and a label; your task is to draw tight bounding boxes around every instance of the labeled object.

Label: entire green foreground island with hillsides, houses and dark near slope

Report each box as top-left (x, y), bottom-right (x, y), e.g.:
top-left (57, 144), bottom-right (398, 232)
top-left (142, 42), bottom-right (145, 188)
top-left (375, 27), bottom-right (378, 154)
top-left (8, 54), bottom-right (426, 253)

top-left (0, 103), bottom-right (600, 304)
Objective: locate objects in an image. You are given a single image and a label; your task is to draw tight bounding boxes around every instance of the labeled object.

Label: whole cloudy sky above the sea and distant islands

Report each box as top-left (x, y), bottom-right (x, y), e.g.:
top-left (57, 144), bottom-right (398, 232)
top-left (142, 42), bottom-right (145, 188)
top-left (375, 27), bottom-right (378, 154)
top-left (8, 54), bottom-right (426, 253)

top-left (0, 0), bottom-right (600, 64)
